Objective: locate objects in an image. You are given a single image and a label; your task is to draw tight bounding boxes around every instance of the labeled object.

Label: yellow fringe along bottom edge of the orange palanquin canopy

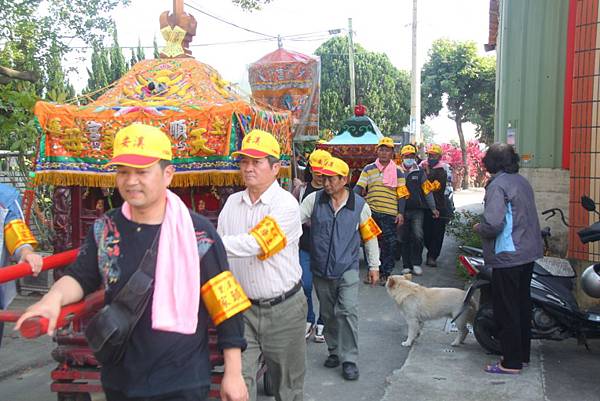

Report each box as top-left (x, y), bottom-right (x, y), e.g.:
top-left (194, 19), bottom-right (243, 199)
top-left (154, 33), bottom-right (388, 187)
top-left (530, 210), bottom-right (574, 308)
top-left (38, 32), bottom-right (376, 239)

top-left (33, 167), bottom-right (291, 188)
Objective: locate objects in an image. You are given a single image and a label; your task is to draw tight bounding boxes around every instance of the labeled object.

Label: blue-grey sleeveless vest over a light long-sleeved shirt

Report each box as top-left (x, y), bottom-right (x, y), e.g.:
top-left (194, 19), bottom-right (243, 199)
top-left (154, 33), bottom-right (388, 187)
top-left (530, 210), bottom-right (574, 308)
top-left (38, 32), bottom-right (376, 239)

top-left (310, 190), bottom-right (365, 279)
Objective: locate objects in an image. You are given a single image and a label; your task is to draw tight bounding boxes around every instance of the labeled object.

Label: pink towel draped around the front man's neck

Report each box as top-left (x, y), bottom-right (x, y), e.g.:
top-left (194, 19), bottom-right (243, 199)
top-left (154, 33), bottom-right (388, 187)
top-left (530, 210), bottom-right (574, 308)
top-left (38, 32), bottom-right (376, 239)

top-left (121, 190), bottom-right (200, 334)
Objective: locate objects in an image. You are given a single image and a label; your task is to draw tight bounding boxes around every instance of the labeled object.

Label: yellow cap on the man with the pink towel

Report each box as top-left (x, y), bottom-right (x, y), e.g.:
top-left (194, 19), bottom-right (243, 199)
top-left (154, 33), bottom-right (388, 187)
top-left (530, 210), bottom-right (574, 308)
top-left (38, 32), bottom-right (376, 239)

top-left (106, 123), bottom-right (173, 168)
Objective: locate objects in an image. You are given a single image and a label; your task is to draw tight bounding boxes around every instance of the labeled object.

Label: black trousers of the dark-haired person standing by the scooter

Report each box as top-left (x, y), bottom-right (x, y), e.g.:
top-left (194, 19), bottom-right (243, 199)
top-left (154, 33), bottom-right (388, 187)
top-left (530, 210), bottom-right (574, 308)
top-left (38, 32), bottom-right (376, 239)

top-left (492, 263), bottom-right (533, 369)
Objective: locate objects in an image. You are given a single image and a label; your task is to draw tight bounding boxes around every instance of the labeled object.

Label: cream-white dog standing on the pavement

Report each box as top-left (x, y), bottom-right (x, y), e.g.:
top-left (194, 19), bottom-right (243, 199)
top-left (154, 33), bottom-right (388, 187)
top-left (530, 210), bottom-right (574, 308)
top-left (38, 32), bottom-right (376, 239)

top-left (385, 274), bottom-right (477, 347)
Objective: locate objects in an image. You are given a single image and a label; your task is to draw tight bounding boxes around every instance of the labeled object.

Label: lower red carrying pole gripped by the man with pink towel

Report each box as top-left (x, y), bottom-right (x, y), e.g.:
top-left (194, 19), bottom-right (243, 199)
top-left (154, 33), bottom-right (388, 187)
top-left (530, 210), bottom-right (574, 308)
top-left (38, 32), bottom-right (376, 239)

top-left (20, 290), bottom-right (104, 338)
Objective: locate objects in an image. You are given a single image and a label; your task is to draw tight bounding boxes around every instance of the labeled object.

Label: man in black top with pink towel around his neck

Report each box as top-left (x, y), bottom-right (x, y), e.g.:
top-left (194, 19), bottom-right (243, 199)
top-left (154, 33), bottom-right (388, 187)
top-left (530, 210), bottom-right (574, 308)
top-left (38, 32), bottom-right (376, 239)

top-left (16, 124), bottom-right (249, 401)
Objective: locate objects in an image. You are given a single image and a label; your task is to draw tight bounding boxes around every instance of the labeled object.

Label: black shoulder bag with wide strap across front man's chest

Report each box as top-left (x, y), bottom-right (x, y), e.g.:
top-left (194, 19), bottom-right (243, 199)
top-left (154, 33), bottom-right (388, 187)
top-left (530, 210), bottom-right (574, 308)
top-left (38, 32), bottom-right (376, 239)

top-left (85, 229), bottom-right (160, 365)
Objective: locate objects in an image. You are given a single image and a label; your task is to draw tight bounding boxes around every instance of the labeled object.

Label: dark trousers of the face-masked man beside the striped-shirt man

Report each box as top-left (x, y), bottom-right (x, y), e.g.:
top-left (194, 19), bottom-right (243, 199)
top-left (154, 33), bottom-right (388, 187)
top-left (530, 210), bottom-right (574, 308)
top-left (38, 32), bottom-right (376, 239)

top-left (400, 209), bottom-right (425, 269)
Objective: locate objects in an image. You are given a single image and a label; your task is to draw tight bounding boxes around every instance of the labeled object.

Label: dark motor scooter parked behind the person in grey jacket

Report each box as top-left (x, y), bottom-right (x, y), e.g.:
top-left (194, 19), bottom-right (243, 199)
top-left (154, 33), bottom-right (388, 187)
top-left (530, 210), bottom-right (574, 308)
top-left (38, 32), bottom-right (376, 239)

top-left (459, 197), bottom-right (600, 354)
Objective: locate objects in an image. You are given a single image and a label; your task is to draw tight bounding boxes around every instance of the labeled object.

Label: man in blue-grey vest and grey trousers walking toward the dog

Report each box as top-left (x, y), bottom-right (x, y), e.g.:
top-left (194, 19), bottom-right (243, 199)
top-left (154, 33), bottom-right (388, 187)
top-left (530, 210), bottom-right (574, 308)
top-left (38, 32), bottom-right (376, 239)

top-left (300, 157), bottom-right (381, 380)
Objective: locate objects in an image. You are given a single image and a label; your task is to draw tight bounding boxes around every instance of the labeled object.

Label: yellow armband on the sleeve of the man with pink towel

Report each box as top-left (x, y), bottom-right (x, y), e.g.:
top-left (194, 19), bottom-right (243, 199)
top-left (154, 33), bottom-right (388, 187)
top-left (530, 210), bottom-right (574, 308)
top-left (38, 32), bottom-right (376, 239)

top-left (200, 271), bottom-right (251, 326)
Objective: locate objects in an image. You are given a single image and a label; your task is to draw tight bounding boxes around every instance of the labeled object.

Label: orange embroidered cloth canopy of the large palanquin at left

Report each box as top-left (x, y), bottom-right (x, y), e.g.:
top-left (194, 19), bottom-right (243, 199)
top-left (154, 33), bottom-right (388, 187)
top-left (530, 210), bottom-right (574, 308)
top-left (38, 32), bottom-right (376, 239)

top-left (34, 58), bottom-right (292, 187)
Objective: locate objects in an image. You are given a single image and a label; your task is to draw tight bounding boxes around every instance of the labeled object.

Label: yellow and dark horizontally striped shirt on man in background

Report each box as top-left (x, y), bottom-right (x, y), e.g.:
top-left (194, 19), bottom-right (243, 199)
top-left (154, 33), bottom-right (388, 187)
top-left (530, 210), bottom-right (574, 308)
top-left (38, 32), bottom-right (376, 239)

top-left (356, 163), bottom-right (406, 216)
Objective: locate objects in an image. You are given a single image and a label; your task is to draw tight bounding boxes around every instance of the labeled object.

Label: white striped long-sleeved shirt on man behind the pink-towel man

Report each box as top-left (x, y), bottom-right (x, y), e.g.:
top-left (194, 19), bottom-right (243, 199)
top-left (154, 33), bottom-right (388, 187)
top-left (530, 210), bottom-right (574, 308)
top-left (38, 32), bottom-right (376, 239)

top-left (217, 181), bottom-right (302, 300)
